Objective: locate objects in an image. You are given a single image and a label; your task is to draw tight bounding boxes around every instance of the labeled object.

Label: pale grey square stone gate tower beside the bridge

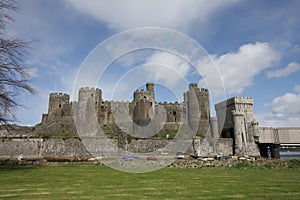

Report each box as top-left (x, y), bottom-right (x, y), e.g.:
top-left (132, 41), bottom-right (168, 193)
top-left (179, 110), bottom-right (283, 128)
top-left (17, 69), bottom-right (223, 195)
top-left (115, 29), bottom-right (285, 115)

top-left (215, 97), bottom-right (259, 155)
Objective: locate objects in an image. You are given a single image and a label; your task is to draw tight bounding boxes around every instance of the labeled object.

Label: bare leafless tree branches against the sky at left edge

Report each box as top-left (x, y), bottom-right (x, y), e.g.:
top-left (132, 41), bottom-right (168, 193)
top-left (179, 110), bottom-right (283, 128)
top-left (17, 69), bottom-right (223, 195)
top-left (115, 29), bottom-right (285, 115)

top-left (0, 0), bottom-right (34, 124)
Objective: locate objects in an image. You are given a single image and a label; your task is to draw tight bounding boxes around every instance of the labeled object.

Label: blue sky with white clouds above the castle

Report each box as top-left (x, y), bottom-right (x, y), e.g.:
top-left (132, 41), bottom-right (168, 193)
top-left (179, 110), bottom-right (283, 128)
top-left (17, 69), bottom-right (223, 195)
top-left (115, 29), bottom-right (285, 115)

top-left (7, 0), bottom-right (300, 127)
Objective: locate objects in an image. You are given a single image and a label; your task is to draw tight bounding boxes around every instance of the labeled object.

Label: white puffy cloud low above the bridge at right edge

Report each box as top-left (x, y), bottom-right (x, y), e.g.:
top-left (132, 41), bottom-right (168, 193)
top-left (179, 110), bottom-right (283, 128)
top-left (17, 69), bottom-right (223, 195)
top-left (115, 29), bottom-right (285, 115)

top-left (256, 85), bottom-right (300, 127)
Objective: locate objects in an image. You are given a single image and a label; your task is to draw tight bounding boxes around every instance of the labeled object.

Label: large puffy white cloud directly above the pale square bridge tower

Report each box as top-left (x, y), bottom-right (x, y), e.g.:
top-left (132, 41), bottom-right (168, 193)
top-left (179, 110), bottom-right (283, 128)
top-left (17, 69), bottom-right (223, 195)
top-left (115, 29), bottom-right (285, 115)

top-left (199, 42), bottom-right (280, 94)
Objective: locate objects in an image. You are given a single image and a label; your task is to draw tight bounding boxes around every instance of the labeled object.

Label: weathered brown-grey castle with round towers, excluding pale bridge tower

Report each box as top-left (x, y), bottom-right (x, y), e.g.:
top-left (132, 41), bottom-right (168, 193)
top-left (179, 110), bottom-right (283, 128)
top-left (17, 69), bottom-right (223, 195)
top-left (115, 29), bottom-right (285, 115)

top-left (36, 83), bottom-right (210, 135)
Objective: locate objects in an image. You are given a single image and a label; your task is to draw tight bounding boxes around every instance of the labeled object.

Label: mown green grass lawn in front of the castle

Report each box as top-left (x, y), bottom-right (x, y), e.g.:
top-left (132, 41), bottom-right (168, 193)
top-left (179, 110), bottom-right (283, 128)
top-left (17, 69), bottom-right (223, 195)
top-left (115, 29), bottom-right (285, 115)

top-left (0, 166), bottom-right (300, 200)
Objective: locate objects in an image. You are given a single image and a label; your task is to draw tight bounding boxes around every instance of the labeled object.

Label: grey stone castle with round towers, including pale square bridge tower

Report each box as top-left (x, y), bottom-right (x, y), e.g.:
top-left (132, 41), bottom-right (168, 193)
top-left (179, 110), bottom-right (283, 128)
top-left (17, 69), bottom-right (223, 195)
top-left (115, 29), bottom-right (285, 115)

top-left (36, 83), bottom-right (259, 156)
